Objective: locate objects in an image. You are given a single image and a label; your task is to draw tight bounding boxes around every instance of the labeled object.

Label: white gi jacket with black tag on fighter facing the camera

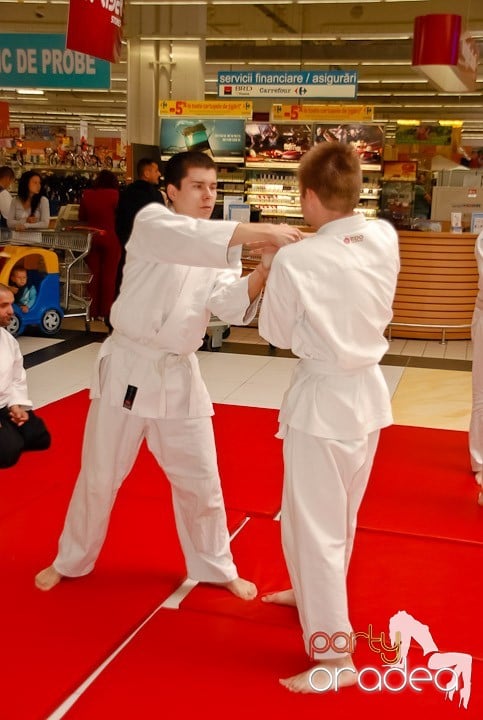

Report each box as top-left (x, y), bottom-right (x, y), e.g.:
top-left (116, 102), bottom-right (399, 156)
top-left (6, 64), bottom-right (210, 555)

top-left (95, 203), bottom-right (258, 418)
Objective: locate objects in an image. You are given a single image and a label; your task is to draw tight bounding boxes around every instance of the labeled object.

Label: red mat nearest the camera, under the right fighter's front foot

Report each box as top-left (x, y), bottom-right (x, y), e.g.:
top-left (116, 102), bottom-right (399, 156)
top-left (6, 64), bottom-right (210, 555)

top-left (65, 601), bottom-right (483, 720)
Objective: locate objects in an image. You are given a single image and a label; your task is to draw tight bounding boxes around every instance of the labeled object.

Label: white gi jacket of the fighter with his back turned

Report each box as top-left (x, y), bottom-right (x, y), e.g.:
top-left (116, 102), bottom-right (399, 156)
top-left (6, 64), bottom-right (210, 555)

top-left (259, 214), bottom-right (399, 440)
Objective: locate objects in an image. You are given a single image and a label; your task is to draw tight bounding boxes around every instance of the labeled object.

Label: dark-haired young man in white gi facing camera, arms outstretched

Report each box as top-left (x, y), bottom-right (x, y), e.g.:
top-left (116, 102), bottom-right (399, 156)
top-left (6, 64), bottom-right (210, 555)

top-left (36, 153), bottom-right (299, 599)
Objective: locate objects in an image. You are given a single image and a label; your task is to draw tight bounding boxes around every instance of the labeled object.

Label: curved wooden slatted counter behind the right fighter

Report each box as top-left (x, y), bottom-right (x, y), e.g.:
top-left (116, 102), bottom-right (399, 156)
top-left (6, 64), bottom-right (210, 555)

top-left (390, 230), bottom-right (478, 340)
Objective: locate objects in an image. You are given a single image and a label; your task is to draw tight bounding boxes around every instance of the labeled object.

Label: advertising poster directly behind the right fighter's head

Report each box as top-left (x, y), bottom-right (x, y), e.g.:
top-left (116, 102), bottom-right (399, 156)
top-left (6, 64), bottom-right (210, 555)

top-left (314, 123), bottom-right (384, 169)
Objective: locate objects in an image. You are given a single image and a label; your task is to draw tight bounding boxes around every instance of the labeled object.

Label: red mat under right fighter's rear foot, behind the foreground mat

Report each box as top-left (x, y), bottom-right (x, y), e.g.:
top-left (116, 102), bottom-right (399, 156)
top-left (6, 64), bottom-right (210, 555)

top-left (181, 519), bottom-right (483, 660)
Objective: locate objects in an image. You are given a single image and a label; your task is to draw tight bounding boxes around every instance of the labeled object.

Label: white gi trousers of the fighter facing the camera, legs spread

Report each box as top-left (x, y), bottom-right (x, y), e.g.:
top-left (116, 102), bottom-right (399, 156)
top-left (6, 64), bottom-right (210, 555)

top-left (54, 358), bottom-right (237, 583)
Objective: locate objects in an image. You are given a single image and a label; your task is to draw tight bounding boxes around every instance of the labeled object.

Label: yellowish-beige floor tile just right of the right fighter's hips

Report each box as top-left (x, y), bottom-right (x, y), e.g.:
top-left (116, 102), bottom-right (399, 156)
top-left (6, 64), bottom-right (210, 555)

top-left (392, 368), bottom-right (471, 430)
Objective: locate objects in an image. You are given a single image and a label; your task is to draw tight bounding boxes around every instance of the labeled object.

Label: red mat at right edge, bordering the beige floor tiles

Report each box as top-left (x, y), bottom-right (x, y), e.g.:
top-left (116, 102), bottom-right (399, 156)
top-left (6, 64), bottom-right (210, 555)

top-left (359, 425), bottom-right (483, 543)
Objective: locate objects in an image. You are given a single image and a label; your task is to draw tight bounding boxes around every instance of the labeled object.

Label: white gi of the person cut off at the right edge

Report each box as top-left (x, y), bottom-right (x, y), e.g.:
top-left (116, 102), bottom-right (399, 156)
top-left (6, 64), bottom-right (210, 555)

top-left (469, 232), bottom-right (483, 472)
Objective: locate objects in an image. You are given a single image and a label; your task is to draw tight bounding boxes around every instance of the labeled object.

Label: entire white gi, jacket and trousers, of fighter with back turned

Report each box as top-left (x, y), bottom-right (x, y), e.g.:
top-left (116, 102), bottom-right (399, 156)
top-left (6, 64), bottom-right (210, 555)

top-left (259, 214), bottom-right (399, 659)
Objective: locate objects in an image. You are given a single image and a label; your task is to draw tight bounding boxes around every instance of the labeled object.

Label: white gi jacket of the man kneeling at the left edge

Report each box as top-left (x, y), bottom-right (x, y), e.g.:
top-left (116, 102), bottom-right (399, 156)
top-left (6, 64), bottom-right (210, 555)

top-left (0, 328), bottom-right (32, 410)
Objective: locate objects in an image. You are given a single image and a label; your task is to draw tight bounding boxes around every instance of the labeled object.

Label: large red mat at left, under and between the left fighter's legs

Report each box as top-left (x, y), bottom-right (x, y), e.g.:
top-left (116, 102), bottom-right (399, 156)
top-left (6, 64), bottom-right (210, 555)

top-left (0, 393), bottom-right (245, 720)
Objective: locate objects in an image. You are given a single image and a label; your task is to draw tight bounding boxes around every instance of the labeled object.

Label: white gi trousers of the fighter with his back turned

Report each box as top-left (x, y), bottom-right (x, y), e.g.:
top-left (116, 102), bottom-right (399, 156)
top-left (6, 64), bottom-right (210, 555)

top-left (282, 427), bottom-right (379, 660)
